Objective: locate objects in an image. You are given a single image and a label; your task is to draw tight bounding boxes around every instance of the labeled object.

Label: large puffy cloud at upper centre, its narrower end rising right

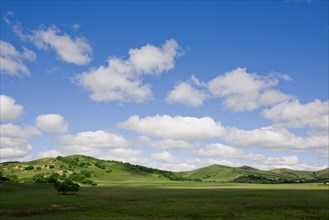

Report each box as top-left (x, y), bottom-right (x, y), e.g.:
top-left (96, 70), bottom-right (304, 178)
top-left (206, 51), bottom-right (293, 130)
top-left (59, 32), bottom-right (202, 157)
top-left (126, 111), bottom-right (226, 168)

top-left (76, 40), bottom-right (178, 103)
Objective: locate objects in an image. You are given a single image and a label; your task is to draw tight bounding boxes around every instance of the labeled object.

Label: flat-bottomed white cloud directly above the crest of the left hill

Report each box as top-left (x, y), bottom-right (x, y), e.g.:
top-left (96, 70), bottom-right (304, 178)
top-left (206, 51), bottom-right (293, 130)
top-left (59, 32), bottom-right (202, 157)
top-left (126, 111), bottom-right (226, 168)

top-left (59, 130), bottom-right (128, 148)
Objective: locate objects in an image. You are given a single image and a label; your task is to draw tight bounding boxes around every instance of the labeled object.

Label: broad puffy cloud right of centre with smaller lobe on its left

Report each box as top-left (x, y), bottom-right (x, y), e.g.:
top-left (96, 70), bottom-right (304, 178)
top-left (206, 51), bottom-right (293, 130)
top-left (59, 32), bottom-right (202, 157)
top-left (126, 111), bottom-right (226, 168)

top-left (166, 68), bottom-right (293, 109)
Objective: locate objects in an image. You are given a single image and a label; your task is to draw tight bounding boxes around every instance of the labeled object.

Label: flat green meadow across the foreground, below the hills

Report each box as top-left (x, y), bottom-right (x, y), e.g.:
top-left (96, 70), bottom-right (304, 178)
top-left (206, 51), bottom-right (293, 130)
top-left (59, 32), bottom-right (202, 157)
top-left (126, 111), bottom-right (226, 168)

top-left (0, 182), bottom-right (329, 219)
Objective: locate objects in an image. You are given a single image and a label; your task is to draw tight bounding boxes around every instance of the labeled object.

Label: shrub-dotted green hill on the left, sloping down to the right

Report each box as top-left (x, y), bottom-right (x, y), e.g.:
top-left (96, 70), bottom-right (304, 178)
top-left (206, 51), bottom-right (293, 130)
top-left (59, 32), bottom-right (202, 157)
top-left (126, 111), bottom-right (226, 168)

top-left (1, 155), bottom-right (183, 185)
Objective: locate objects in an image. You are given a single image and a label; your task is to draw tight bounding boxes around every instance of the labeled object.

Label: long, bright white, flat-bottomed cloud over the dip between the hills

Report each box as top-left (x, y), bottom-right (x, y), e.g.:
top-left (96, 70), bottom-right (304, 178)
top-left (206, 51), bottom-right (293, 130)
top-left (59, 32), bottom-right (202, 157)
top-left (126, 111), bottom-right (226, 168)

top-left (119, 115), bottom-right (225, 141)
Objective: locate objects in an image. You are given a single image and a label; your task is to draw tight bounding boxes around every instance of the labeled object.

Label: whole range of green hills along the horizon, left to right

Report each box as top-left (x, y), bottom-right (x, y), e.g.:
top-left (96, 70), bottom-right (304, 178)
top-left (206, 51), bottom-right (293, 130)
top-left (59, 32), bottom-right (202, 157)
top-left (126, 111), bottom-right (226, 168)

top-left (0, 155), bottom-right (329, 185)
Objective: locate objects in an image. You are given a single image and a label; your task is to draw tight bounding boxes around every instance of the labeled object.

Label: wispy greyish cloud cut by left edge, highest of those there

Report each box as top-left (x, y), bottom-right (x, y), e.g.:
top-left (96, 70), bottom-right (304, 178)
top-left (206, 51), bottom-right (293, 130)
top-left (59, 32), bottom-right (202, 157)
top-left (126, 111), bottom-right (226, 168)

top-left (0, 40), bottom-right (36, 76)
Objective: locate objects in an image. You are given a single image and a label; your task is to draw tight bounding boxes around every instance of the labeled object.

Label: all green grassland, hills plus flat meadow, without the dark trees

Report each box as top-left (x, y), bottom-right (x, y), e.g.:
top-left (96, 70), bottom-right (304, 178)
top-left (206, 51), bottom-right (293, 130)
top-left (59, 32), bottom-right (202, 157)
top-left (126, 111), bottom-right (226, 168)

top-left (0, 156), bottom-right (329, 220)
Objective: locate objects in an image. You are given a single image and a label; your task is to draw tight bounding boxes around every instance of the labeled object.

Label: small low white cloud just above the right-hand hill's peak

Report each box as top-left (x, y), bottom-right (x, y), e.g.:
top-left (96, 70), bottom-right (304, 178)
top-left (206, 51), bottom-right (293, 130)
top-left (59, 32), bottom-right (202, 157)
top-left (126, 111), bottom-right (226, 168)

top-left (197, 143), bottom-right (243, 158)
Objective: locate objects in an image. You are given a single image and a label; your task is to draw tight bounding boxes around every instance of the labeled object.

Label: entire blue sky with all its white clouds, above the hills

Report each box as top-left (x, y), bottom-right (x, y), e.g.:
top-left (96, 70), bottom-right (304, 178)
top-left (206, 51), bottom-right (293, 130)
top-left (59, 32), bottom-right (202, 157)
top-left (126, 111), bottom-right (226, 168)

top-left (0, 0), bottom-right (329, 171)
